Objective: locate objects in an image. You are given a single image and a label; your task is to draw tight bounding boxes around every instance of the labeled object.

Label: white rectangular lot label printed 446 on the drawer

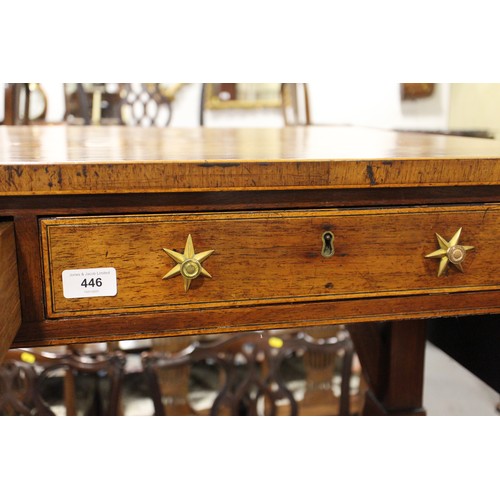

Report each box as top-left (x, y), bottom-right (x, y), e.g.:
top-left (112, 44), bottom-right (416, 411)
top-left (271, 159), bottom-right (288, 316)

top-left (62, 267), bottom-right (117, 299)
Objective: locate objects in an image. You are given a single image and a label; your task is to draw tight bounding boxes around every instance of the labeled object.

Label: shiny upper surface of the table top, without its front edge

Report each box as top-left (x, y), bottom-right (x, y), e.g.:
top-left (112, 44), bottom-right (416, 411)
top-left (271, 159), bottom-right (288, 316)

top-left (0, 125), bottom-right (500, 165)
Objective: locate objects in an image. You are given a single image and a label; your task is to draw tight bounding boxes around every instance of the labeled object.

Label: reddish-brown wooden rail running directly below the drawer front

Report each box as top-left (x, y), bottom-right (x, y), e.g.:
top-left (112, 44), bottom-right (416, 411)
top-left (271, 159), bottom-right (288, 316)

top-left (14, 290), bottom-right (500, 346)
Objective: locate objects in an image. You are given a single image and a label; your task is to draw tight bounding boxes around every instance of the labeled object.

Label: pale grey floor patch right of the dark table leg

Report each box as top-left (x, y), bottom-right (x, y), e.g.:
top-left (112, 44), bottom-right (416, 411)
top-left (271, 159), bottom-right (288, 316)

top-left (424, 342), bottom-right (500, 416)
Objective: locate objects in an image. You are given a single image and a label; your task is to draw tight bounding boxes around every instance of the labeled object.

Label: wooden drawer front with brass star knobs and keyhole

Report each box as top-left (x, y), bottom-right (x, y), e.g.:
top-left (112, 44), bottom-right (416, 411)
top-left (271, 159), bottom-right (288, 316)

top-left (41, 205), bottom-right (500, 318)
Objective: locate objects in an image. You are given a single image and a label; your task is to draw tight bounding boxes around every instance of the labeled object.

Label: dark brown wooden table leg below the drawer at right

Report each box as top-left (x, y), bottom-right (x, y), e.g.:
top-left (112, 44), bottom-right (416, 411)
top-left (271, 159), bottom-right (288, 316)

top-left (349, 320), bottom-right (426, 415)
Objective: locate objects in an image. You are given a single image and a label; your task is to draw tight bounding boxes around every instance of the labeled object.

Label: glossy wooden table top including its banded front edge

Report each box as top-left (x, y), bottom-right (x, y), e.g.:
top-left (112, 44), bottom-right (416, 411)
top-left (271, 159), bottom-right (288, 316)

top-left (0, 125), bottom-right (500, 195)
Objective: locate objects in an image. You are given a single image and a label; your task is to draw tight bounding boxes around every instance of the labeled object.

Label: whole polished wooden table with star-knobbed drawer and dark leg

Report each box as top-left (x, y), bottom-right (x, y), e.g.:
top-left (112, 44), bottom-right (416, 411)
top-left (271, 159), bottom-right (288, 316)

top-left (0, 125), bottom-right (500, 415)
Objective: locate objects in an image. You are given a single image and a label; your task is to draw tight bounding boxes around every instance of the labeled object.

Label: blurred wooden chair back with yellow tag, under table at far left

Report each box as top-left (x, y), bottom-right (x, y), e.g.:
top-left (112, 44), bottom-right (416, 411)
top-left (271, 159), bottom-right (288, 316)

top-left (0, 348), bottom-right (125, 416)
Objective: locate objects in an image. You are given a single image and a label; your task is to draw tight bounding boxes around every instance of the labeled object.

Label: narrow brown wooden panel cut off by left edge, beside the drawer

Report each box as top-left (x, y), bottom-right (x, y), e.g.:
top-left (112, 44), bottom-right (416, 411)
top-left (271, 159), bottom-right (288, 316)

top-left (0, 222), bottom-right (21, 361)
